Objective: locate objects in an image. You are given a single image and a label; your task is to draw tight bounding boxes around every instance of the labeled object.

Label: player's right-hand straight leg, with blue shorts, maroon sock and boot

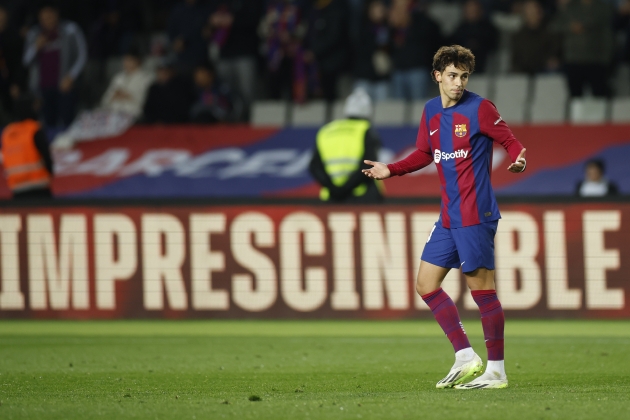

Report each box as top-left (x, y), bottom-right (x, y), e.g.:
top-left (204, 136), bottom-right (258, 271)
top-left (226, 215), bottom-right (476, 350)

top-left (453, 222), bottom-right (508, 389)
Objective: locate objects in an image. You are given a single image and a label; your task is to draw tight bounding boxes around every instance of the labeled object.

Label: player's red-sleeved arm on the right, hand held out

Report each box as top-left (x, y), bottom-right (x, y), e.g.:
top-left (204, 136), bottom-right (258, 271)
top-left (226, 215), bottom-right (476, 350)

top-left (478, 99), bottom-right (527, 173)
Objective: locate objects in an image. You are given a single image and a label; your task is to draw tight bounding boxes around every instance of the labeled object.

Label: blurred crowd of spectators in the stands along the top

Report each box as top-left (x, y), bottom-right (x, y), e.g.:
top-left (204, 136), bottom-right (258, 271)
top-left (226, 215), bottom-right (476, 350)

top-left (0, 0), bottom-right (630, 129)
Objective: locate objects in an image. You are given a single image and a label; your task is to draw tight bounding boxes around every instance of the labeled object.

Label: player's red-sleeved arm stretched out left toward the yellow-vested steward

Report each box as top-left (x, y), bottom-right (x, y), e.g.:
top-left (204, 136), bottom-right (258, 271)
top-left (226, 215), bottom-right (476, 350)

top-left (363, 107), bottom-right (433, 179)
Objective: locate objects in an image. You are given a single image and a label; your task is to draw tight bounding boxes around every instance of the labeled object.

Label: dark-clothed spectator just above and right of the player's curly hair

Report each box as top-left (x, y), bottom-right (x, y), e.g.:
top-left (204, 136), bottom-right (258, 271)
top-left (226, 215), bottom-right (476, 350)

top-left (452, 0), bottom-right (499, 73)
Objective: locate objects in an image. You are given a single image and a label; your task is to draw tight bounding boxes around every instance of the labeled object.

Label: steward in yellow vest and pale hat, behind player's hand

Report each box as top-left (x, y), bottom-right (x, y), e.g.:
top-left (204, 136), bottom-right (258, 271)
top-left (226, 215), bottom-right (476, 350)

top-left (309, 90), bottom-right (383, 203)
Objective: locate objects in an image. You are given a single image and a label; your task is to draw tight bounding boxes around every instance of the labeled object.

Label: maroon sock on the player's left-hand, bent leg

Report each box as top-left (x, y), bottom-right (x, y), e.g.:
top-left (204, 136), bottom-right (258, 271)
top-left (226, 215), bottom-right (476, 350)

top-left (422, 288), bottom-right (470, 352)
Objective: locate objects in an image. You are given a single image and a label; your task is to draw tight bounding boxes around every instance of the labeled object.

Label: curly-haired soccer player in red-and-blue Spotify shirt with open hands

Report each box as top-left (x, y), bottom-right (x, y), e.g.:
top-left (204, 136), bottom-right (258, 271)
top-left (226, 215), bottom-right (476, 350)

top-left (363, 45), bottom-right (526, 389)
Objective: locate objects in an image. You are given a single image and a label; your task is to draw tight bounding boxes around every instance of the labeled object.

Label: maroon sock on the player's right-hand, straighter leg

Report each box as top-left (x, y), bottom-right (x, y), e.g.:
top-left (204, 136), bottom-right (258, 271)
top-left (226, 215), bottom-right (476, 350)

top-left (470, 290), bottom-right (505, 360)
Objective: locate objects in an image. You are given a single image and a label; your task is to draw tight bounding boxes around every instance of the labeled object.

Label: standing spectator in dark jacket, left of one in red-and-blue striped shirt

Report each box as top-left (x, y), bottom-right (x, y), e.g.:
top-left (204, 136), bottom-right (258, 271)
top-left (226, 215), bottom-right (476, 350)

top-left (209, 0), bottom-right (265, 113)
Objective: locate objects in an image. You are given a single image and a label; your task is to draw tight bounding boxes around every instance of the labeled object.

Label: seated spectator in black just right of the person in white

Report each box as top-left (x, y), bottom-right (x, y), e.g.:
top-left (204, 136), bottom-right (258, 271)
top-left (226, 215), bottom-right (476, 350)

top-left (142, 61), bottom-right (195, 124)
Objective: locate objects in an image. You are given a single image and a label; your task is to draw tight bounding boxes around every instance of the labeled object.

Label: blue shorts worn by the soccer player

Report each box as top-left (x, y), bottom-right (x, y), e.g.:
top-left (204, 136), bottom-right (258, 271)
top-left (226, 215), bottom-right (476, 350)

top-left (422, 218), bottom-right (499, 273)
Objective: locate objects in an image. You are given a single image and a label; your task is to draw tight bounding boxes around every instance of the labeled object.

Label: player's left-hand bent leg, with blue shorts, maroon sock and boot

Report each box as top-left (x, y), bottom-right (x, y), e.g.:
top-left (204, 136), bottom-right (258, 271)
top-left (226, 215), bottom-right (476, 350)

top-left (416, 222), bottom-right (483, 388)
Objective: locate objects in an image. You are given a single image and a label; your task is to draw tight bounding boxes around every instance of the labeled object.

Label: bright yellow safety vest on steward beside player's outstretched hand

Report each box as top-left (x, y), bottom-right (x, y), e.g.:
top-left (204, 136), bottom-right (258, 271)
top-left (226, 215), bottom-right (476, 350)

top-left (317, 120), bottom-right (370, 201)
